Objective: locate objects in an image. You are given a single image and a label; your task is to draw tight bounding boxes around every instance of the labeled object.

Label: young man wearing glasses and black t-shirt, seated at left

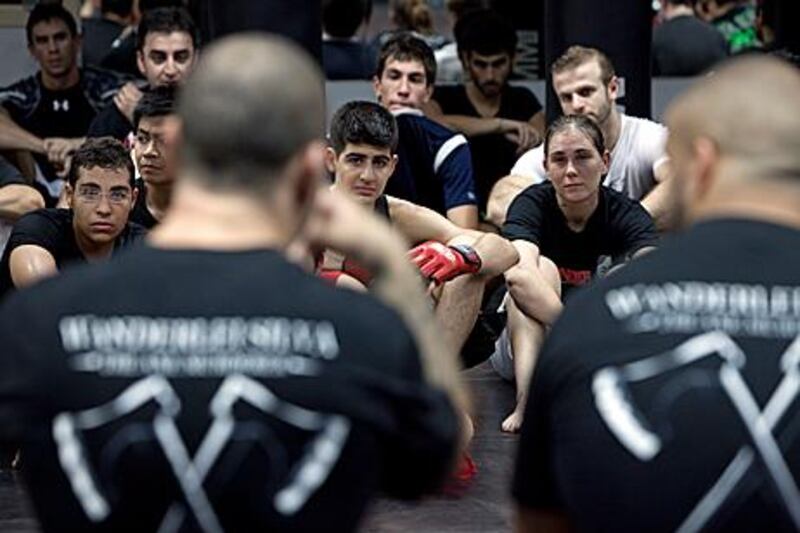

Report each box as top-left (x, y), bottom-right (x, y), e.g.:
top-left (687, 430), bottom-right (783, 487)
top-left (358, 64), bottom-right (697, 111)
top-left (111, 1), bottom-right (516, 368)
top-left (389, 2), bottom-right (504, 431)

top-left (0, 137), bottom-right (145, 296)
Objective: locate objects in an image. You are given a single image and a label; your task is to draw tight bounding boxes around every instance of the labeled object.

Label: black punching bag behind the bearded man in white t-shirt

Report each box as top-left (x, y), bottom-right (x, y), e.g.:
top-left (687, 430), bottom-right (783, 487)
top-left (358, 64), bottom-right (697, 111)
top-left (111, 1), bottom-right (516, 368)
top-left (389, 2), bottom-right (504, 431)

top-left (544, 0), bottom-right (653, 122)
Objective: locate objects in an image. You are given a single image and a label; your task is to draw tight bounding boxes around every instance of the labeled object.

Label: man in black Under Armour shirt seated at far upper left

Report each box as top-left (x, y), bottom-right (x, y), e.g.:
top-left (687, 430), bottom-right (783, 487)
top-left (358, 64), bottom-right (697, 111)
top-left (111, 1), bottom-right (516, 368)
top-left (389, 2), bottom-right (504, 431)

top-left (0, 3), bottom-right (124, 205)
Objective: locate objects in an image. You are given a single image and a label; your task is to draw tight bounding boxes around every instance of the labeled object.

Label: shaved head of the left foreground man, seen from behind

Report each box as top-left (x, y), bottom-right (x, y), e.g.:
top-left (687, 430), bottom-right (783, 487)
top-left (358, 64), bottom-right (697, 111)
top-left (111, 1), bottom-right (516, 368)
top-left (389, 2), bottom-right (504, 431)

top-left (178, 34), bottom-right (325, 188)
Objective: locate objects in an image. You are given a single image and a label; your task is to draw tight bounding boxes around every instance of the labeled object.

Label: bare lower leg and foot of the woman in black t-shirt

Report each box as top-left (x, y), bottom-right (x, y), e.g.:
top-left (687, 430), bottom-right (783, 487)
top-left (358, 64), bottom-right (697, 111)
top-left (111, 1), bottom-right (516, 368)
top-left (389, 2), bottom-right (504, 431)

top-left (500, 257), bottom-right (561, 433)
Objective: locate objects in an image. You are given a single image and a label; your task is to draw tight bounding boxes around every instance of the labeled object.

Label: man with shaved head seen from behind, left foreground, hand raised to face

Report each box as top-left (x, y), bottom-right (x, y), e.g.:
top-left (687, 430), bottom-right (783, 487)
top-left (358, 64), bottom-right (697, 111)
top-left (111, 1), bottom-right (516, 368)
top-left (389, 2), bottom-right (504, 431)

top-left (0, 34), bottom-right (465, 532)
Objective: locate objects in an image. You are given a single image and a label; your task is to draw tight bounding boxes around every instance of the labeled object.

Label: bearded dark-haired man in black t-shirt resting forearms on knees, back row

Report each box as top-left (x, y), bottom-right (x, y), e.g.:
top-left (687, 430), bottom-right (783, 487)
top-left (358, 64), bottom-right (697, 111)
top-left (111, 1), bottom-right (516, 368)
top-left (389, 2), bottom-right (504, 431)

top-left (426, 9), bottom-right (544, 213)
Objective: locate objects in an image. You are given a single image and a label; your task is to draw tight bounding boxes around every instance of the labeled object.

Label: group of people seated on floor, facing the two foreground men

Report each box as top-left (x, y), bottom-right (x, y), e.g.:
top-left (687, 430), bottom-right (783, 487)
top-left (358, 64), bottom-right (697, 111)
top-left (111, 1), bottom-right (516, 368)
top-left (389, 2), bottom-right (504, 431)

top-left (0, 5), bottom-right (669, 432)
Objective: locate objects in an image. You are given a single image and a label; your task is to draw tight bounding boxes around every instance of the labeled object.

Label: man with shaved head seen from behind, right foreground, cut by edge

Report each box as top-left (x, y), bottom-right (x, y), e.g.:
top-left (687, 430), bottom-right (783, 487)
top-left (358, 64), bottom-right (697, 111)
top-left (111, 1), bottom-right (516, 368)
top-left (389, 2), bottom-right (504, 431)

top-left (513, 56), bottom-right (800, 532)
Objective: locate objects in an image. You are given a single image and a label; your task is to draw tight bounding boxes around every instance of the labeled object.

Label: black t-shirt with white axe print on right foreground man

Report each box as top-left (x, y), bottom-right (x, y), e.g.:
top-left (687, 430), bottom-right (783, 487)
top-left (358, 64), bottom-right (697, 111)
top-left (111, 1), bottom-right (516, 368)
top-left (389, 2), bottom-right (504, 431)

top-left (513, 219), bottom-right (800, 532)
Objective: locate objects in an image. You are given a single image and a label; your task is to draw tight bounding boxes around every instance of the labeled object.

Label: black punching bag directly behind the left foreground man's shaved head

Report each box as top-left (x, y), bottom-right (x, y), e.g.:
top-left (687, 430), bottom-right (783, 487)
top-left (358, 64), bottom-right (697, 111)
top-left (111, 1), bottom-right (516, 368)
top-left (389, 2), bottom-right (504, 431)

top-left (189, 0), bottom-right (322, 64)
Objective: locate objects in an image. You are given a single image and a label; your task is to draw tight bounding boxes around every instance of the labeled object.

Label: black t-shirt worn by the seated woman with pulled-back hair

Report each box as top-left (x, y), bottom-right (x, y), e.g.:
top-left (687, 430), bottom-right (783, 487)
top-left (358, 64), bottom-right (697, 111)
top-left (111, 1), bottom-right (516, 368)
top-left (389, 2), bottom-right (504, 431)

top-left (503, 181), bottom-right (658, 291)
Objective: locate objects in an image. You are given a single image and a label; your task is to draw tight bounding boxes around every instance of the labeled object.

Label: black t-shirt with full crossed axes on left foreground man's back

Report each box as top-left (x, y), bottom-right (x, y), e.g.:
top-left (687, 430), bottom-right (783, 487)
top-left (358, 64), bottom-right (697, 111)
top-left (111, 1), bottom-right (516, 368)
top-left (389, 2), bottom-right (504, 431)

top-left (0, 246), bottom-right (457, 531)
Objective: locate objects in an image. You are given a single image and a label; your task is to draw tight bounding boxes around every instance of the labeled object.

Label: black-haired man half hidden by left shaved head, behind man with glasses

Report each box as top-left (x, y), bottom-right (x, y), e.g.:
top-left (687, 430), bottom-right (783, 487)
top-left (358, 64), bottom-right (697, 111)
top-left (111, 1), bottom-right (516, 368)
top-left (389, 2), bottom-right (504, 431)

top-left (131, 86), bottom-right (175, 229)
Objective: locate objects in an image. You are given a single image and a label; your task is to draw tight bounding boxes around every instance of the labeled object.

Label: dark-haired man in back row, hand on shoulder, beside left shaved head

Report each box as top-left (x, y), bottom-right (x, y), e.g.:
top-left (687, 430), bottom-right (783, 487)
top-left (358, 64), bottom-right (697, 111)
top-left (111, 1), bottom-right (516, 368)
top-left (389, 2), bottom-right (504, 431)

top-left (88, 7), bottom-right (199, 141)
